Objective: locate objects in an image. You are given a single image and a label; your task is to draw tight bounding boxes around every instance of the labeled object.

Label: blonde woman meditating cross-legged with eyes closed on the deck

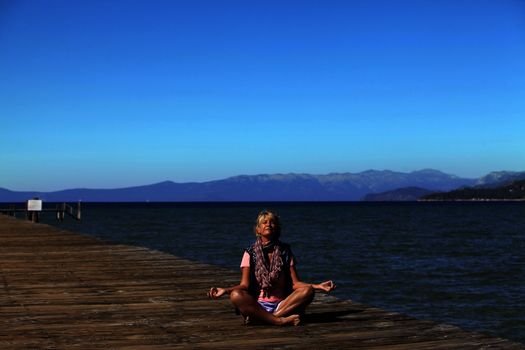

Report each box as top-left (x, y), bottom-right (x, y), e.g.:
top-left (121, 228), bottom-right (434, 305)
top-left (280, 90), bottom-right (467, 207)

top-left (208, 211), bottom-right (335, 325)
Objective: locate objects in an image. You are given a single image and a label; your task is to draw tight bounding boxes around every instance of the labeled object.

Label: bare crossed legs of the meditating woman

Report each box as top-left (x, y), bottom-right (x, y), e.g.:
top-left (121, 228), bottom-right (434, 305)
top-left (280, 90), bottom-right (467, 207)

top-left (230, 286), bottom-right (315, 325)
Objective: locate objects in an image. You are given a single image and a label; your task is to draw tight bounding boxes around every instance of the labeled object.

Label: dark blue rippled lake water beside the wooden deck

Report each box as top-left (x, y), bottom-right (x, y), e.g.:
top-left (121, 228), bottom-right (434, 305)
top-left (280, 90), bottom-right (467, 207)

top-left (43, 202), bottom-right (525, 342)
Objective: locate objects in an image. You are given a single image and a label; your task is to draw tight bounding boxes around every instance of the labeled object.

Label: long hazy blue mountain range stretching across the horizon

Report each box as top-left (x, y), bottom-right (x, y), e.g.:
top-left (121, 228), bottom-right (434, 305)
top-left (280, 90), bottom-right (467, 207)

top-left (0, 169), bottom-right (477, 202)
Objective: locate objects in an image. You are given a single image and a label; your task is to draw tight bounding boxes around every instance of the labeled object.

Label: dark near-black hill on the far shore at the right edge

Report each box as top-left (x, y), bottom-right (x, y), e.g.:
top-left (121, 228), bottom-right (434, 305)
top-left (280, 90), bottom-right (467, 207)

top-left (421, 180), bottom-right (525, 201)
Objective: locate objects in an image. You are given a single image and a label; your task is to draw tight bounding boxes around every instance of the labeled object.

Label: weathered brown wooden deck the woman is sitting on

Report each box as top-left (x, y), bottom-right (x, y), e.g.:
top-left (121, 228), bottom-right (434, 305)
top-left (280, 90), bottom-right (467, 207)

top-left (0, 215), bottom-right (525, 349)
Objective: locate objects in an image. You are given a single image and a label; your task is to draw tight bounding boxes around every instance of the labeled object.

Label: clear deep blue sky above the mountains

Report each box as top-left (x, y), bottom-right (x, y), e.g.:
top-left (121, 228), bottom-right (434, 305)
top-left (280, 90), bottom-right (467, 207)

top-left (0, 0), bottom-right (525, 191)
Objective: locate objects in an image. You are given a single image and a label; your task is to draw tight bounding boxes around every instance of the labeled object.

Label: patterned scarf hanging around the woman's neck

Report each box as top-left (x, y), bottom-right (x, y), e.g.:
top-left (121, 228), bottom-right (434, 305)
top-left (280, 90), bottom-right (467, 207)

top-left (253, 238), bottom-right (283, 296)
